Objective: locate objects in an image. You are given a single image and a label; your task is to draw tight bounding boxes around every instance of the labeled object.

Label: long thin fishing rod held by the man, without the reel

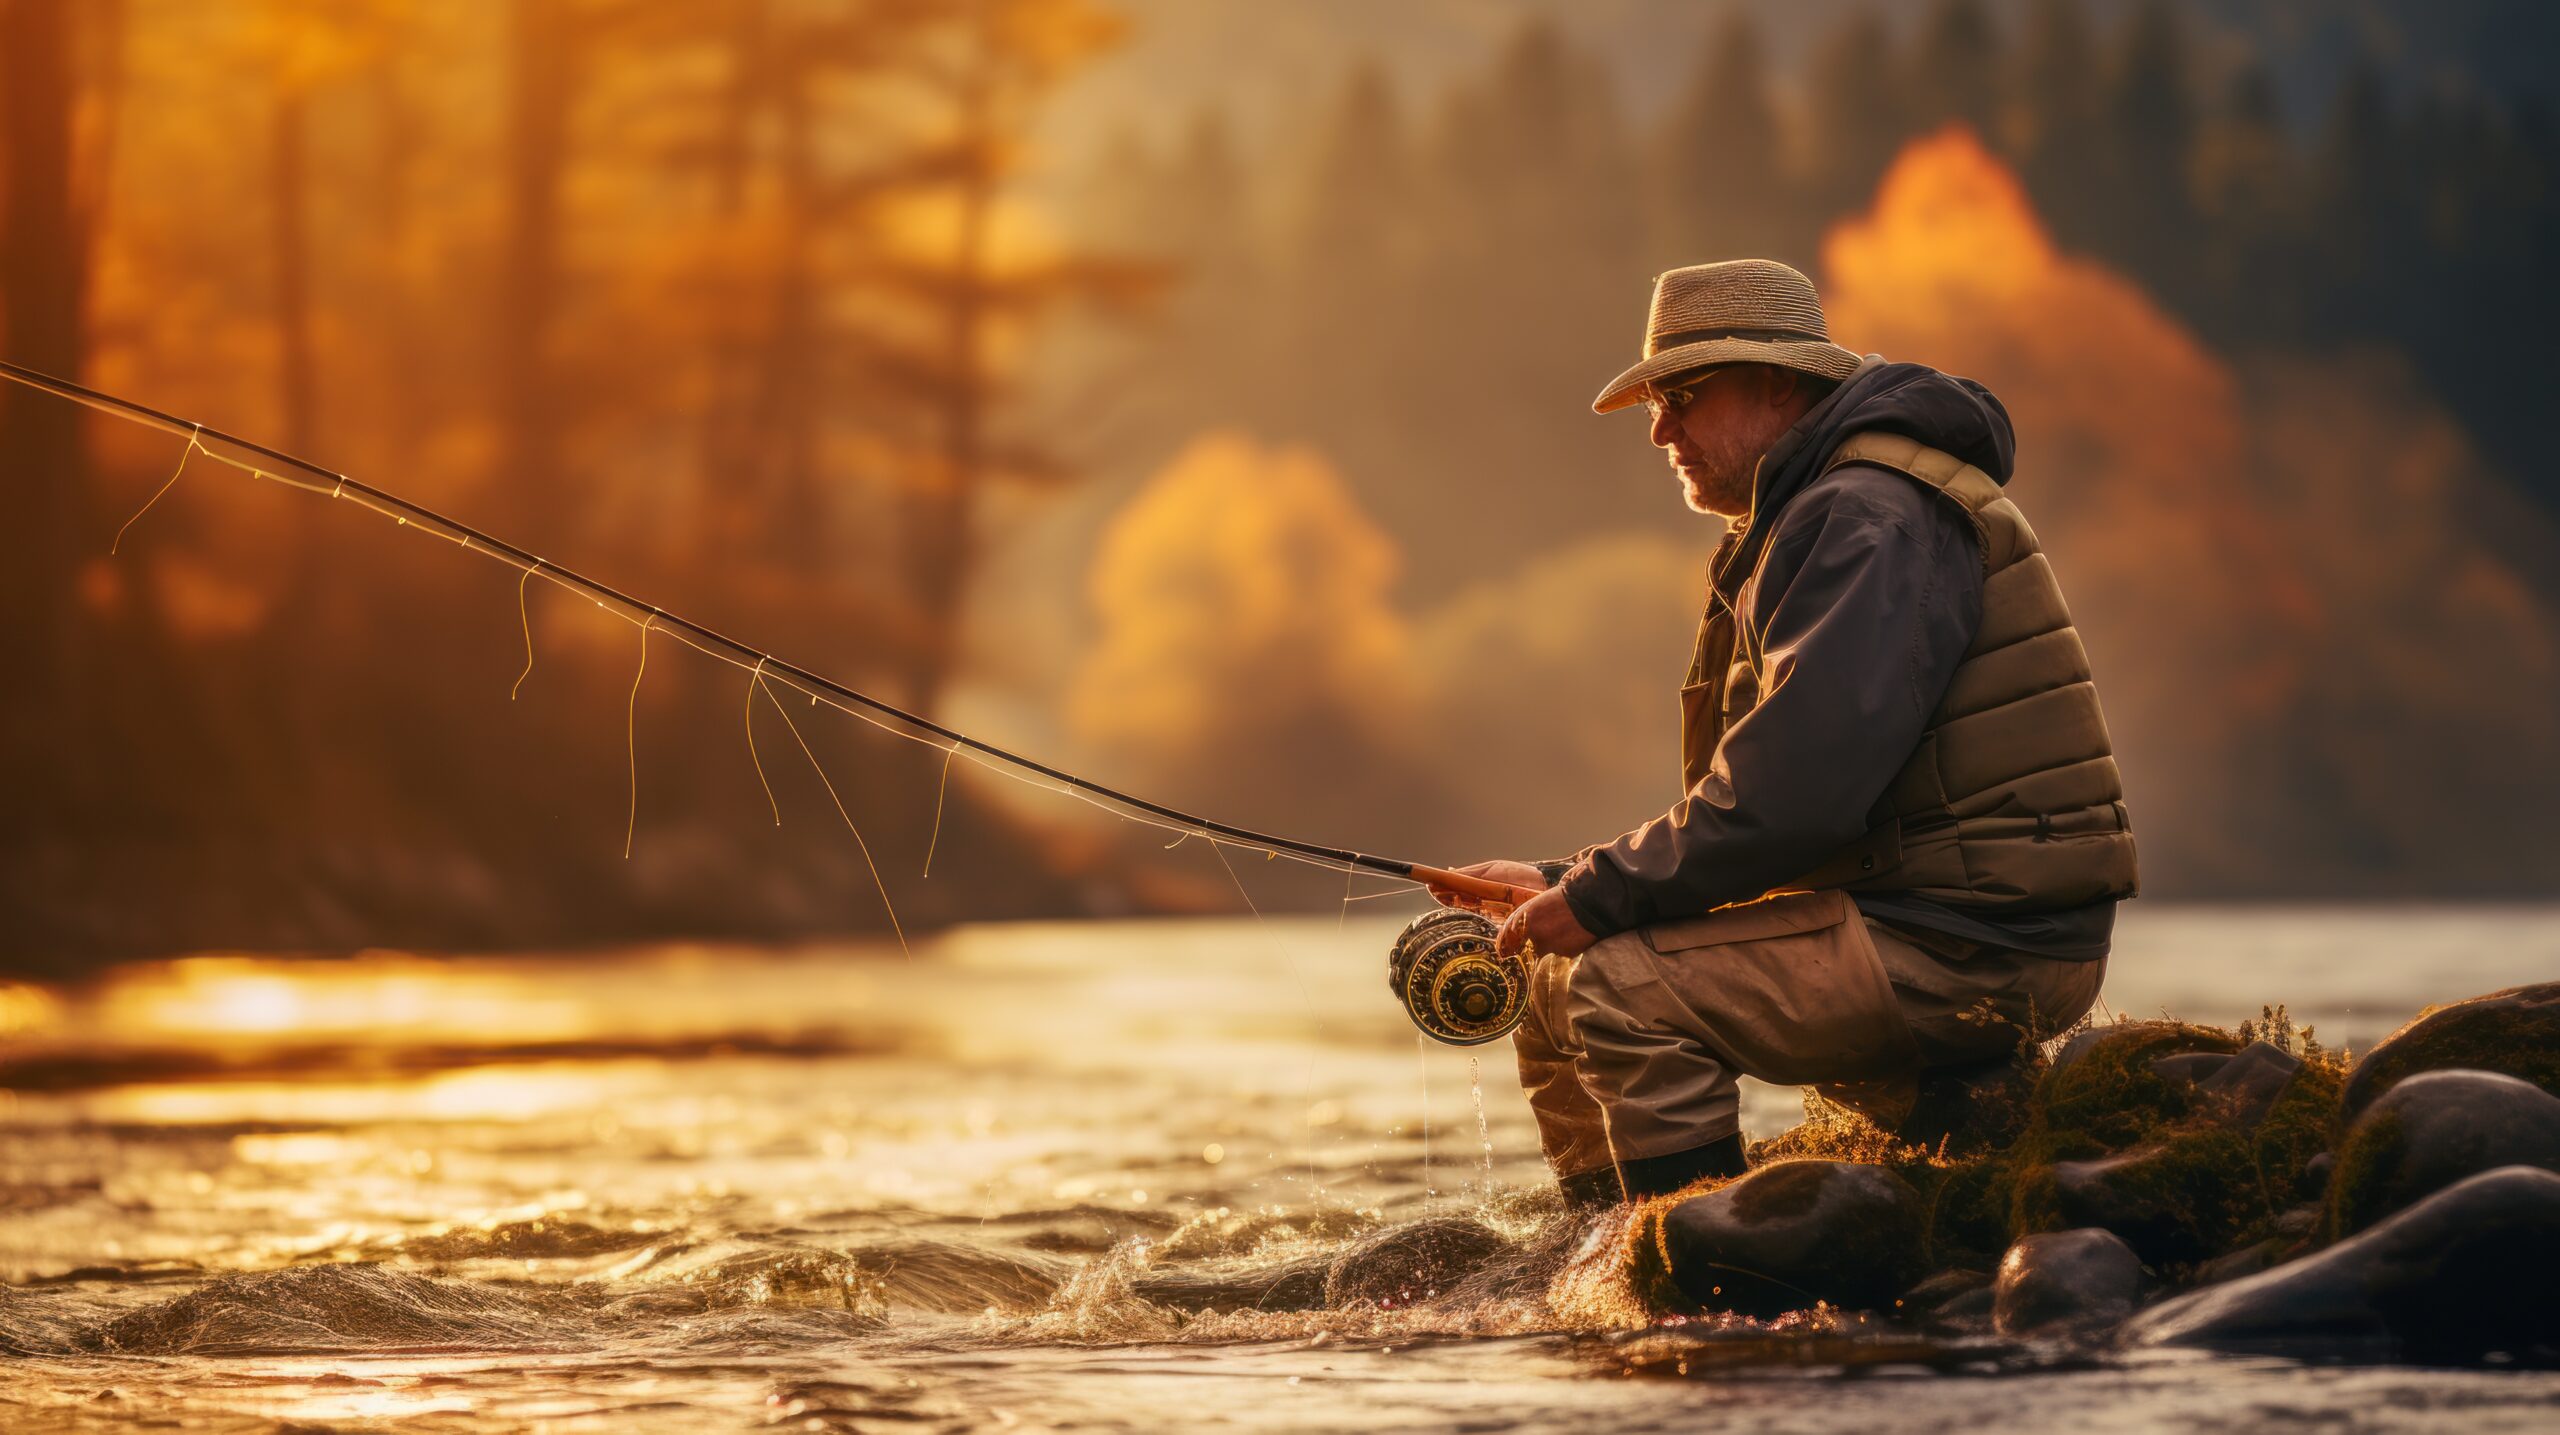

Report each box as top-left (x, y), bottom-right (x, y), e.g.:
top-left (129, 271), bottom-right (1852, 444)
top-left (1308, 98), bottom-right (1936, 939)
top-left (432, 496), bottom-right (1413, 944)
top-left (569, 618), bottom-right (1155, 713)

top-left (0, 361), bottom-right (1536, 906)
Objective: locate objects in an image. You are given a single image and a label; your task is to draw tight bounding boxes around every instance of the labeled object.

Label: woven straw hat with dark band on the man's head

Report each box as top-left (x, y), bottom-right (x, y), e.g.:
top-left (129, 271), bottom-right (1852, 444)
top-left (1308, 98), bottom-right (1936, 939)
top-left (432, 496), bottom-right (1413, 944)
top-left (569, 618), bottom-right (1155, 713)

top-left (1592, 258), bottom-right (1859, 414)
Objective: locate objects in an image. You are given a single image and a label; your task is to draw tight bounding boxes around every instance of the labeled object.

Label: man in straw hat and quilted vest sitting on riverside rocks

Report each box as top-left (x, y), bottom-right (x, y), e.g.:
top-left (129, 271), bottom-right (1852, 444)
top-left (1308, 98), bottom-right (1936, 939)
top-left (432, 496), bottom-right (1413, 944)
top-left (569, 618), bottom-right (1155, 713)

top-left (1434, 258), bottom-right (2135, 1205)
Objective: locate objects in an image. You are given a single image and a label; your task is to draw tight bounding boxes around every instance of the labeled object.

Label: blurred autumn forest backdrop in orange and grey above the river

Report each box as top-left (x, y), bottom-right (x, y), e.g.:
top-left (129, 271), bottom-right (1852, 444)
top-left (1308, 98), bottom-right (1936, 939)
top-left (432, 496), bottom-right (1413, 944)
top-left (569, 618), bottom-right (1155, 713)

top-left (0, 0), bottom-right (2560, 975)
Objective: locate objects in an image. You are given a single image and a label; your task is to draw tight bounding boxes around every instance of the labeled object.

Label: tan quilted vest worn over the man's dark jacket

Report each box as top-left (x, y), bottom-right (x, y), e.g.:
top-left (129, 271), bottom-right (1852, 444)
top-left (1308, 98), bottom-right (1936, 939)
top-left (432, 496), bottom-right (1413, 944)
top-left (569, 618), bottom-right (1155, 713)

top-left (1679, 432), bottom-right (2138, 913)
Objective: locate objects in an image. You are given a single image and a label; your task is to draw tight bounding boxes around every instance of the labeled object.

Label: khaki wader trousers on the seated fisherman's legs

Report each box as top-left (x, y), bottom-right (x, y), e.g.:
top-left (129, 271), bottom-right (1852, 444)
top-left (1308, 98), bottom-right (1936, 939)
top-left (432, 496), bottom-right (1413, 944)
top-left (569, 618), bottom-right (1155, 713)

top-left (1513, 890), bottom-right (2107, 1177)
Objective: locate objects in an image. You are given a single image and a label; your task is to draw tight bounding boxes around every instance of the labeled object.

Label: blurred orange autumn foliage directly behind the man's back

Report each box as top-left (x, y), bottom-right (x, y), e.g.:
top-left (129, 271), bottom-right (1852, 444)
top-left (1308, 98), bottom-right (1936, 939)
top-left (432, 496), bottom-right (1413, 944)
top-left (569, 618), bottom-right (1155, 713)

top-left (1823, 128), bottom-right (2560, 882)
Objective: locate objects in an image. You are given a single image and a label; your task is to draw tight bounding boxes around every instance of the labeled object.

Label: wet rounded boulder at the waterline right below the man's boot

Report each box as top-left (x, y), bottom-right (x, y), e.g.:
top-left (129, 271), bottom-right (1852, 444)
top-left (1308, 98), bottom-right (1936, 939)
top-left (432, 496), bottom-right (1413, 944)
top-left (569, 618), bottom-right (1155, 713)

top-left (1638, 1161), bottom-right (1928, 1315)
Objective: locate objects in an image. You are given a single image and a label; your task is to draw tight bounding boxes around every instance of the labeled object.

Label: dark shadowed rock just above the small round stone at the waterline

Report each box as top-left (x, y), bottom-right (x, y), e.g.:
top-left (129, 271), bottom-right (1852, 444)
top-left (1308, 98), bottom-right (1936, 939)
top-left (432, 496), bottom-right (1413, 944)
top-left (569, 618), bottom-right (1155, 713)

top-left (2053, 1125), bottom-right (2263, 1266)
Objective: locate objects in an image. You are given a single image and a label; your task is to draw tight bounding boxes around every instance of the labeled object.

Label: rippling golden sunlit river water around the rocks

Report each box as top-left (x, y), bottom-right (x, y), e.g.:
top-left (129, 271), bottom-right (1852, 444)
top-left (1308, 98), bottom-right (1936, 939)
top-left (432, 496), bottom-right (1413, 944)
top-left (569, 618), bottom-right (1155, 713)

top-left (0, 900), bottom-right (2560, 1432)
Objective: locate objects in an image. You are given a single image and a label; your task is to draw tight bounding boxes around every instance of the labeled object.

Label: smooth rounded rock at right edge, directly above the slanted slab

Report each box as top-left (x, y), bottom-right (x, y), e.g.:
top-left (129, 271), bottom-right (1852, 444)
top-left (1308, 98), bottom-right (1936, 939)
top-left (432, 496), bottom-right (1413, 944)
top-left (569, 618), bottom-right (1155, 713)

top-left (2327, 1072), bottom-right (2560, 1241)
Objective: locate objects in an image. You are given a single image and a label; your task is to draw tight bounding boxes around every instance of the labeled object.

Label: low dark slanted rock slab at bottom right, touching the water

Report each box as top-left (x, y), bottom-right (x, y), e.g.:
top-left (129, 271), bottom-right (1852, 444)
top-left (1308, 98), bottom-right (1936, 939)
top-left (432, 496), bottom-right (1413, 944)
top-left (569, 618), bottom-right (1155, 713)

top-left (2125, 1166), bottom-right (2560, 1361)
